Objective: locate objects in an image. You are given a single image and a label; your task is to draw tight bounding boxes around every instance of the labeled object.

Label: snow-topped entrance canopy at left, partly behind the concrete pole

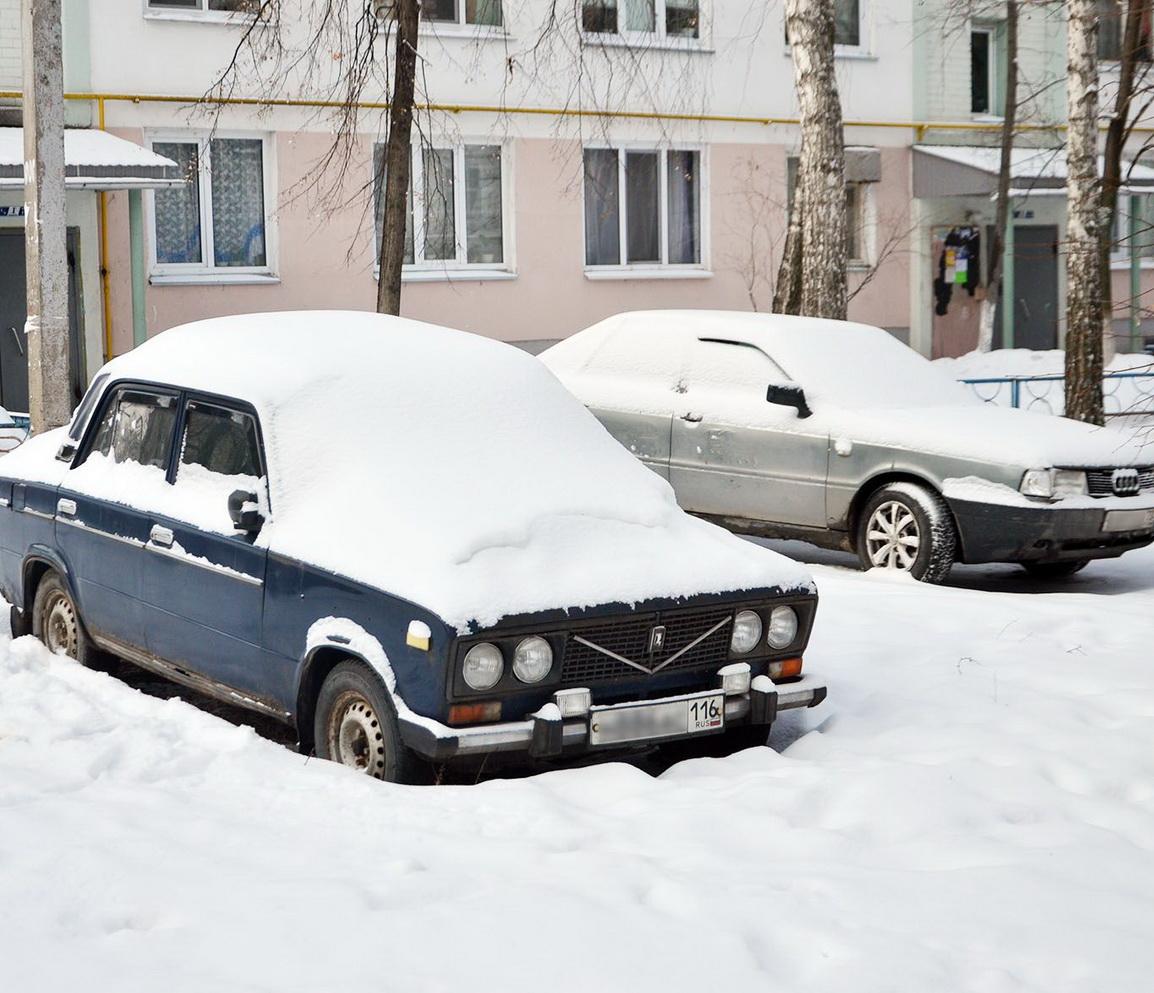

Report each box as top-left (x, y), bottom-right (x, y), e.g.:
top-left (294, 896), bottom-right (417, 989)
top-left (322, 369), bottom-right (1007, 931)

top-left (0, 127), bottom-right (185, 189)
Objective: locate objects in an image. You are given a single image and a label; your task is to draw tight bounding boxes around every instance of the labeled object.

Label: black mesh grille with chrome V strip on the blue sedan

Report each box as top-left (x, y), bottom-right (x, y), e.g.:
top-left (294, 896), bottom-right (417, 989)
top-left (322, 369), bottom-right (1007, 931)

top-left (561, 607), bottom-right (733, 686)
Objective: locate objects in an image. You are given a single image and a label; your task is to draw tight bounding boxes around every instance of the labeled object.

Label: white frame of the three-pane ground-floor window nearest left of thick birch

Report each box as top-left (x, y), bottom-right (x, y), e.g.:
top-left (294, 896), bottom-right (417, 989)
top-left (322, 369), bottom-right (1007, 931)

top-left (580, 142), bottom-right (713, 279)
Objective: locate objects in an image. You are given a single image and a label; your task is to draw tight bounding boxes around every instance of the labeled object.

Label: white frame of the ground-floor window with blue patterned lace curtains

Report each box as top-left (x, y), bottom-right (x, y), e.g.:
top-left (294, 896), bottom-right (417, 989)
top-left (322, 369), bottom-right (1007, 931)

top-left (144, 130), bottom-right (278, 285)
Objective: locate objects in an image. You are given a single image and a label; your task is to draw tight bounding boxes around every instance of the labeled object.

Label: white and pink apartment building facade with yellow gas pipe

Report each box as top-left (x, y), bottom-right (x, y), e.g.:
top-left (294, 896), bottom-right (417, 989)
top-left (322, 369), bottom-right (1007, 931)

top-left (0, 0), bottom-right (1145, 408)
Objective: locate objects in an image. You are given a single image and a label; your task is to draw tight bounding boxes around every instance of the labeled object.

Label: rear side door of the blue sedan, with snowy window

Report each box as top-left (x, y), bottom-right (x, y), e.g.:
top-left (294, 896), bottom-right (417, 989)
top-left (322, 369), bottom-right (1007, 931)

top-left (54, 387), bottom-right (179, 651)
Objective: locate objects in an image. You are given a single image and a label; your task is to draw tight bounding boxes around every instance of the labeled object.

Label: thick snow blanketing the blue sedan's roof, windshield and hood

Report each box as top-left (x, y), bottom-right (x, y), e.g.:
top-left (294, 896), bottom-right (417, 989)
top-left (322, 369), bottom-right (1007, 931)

top-left (5, 312), bottom-right (812, 628)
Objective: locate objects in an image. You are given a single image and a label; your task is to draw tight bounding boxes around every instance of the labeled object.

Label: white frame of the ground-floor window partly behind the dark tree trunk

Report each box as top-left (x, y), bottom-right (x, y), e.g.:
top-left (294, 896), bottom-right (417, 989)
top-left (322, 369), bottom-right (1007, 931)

top-left (370, 136), bottom-right (516, 283)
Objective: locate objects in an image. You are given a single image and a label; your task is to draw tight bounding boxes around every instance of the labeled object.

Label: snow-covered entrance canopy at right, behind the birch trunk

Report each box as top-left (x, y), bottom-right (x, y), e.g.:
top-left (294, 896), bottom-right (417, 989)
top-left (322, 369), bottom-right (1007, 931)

top-left (914, 144), bottom-right (1154, 197)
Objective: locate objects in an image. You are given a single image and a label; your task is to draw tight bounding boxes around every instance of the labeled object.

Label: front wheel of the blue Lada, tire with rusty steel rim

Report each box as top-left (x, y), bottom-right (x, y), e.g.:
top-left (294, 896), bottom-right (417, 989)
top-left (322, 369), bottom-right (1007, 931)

top-left (313, 659), bottom-right (427, 783)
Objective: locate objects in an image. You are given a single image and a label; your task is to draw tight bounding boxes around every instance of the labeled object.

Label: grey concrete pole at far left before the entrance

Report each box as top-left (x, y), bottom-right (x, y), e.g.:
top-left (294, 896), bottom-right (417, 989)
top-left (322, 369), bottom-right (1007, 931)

top-left (23, 0), bottom-right (72, 433)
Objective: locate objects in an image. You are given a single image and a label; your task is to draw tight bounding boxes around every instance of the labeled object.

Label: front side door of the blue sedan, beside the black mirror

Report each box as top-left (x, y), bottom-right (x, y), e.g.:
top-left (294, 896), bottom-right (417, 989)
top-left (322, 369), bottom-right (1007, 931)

top-left (135, 397), bottom-right (283, 701)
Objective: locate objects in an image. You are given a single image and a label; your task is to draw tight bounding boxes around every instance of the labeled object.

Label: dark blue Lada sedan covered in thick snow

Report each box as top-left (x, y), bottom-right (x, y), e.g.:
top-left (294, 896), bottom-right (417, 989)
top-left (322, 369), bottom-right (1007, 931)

top-left (0, 312), bottom-right (825, 781)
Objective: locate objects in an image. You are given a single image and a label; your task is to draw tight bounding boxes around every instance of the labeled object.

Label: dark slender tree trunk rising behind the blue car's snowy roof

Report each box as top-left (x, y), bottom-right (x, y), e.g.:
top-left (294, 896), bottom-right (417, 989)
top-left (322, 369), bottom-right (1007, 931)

top-left (376, 0), bottom-right (420, 315)
